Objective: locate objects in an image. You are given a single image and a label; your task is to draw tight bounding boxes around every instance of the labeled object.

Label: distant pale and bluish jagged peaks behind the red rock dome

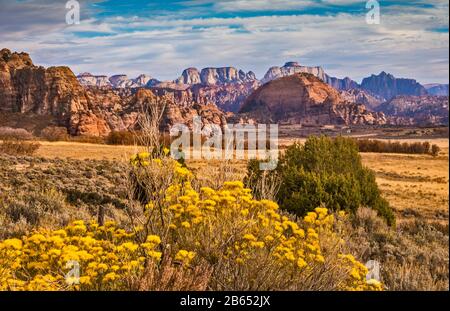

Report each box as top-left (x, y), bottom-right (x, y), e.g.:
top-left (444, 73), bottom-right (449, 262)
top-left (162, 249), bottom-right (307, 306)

top-left (78, 62), bottom-right (448, 112)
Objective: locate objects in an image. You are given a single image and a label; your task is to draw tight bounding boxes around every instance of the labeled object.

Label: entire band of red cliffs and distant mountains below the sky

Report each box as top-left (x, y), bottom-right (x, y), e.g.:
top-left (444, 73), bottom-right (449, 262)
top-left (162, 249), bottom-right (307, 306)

top-left (0, 49), bottom-right (448, 136)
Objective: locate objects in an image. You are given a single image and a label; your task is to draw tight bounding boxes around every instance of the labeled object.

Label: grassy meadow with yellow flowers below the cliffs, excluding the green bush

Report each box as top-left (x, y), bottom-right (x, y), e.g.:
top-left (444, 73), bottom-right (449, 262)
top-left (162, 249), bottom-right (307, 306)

top-left (0, 137), bottom-right (449, 290)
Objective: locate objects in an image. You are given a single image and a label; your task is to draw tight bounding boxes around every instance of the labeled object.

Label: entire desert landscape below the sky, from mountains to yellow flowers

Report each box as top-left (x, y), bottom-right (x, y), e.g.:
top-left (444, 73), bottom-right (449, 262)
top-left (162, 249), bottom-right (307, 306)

top-left (0, 44), bottom-right (449, 290)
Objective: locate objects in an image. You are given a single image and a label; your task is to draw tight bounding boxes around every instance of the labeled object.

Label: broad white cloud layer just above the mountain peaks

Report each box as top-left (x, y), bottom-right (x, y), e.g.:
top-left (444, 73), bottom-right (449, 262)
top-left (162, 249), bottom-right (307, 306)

top-left (0, 0), bottom-right (449, 83)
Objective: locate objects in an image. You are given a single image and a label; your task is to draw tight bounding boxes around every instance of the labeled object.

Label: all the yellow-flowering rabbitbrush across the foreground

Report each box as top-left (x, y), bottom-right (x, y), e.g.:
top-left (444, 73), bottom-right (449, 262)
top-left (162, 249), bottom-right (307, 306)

top-left (0, 159), bottom-right (382, 290)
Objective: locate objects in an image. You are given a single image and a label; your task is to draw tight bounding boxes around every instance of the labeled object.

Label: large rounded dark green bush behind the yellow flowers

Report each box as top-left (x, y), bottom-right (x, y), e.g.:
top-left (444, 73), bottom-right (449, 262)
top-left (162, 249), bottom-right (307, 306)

top-left (245, 136), bottom-right (395, 225)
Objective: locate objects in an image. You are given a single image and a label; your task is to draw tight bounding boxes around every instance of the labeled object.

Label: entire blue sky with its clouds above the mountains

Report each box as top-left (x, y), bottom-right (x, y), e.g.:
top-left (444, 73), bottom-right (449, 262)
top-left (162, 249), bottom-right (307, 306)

top-left (0, 0), bottom-right (449, 84)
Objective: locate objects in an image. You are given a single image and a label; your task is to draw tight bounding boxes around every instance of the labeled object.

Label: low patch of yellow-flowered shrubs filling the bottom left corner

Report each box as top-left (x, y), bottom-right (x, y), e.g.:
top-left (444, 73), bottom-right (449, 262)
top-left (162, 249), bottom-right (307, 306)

top-left (0, 221), bottom-right (161, 290)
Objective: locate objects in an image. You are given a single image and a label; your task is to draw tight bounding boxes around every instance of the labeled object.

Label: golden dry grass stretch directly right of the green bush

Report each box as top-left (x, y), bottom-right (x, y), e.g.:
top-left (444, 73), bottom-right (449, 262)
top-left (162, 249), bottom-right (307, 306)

top-left (362, 141), bottom-right (449, 223)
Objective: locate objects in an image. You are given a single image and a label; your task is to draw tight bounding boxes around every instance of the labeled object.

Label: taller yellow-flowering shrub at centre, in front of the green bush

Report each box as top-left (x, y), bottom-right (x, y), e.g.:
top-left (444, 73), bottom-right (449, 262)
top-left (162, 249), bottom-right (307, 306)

top-left (160, 181), bottom-right (381, 290)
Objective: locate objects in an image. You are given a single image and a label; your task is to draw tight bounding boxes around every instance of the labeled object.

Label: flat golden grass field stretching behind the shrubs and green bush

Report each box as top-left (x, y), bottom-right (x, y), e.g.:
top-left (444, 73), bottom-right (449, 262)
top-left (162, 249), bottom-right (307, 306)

top-left (37, 139), bottom-right (449, 222)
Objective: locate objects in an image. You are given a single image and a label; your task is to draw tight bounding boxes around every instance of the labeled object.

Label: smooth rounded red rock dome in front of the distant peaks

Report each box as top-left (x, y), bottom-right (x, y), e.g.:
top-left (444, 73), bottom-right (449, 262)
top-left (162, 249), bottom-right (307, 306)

top-left (240, 73), bottom-right (386, 126)
